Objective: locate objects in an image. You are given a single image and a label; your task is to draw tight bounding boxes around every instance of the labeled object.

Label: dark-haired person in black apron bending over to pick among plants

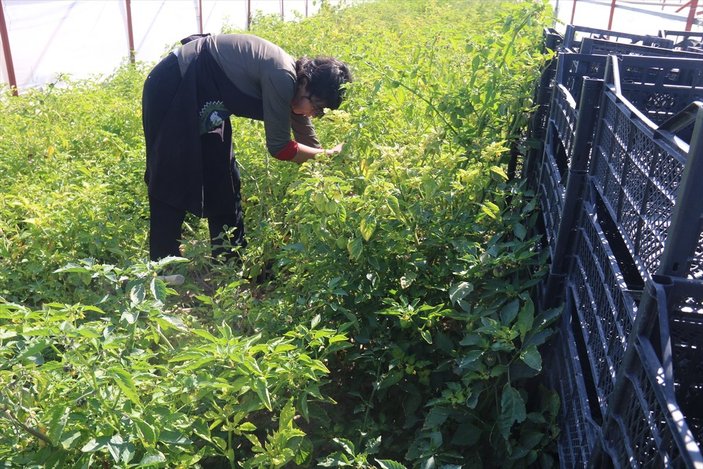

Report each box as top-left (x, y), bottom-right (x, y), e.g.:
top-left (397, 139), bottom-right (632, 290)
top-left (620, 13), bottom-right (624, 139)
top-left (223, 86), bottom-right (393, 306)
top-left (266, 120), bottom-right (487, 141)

top-left (142, 34), bottom-right (351, 260)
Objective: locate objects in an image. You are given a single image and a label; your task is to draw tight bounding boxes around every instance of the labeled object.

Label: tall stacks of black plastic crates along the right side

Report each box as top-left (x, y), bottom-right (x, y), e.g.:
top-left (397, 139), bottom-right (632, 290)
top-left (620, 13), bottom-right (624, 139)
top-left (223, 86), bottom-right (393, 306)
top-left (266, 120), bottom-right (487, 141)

top-left (524, 25), bottom-right (703, 468)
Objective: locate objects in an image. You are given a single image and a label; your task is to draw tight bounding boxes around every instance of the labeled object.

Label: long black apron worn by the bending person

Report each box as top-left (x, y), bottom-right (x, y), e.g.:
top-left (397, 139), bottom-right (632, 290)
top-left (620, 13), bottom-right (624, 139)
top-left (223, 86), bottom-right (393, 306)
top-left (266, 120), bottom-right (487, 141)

top-left (142, 38), bottom-right (264, 217)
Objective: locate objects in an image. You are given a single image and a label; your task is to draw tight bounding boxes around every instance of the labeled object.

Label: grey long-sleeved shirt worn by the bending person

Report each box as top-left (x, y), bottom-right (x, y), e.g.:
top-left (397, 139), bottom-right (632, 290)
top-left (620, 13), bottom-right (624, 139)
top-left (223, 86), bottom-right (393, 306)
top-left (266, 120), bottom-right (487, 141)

top-left (177, 34), bottom-right (320, 156)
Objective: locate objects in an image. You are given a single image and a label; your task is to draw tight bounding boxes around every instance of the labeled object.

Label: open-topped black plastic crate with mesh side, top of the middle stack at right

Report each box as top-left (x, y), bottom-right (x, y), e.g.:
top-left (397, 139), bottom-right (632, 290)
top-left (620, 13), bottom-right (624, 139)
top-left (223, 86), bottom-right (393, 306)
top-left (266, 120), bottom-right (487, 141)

top-left (590, 56), bottom-right (703, 279)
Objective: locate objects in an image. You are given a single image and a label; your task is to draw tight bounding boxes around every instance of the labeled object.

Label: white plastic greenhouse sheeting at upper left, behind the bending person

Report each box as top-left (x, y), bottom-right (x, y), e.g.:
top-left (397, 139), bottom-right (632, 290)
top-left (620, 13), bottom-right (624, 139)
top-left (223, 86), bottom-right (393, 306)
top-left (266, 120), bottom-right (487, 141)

top-left (0, 0), bottom-right (324, 91)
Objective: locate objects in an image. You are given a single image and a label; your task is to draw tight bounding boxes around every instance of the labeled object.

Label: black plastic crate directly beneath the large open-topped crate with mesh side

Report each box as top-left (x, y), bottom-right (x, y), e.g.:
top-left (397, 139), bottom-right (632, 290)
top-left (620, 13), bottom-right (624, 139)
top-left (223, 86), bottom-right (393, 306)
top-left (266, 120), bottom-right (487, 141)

top-left (566, 197), bottom-right (639, 414)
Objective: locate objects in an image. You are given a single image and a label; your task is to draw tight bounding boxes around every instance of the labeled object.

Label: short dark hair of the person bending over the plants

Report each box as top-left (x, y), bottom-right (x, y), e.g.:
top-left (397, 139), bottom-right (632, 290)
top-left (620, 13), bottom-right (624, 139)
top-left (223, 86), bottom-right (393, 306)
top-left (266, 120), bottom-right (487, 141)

top-left (295, 57), bottom-right (352, 109)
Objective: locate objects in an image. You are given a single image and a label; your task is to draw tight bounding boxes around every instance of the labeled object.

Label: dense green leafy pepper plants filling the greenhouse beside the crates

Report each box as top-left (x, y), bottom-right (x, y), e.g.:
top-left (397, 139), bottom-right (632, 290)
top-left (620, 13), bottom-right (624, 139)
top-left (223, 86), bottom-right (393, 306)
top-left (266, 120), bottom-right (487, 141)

top-left (0, 0), bottom-right (558, 468)
